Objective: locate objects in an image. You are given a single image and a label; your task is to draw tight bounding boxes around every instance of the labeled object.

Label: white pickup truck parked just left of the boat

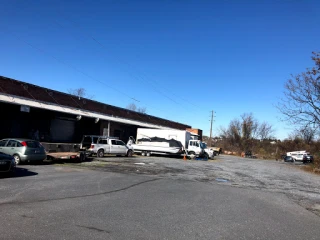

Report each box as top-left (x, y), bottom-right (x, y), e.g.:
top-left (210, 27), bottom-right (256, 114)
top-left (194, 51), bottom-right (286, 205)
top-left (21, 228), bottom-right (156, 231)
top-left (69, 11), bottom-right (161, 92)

top-left (80, 135), bottom-right (133, 158)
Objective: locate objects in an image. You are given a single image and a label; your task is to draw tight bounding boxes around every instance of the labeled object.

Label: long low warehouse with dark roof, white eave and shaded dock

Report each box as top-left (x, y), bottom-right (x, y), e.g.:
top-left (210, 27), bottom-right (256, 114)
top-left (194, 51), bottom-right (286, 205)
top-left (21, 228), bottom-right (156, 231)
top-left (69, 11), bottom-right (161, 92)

top-left (0, 76), bottom-right (202, 143)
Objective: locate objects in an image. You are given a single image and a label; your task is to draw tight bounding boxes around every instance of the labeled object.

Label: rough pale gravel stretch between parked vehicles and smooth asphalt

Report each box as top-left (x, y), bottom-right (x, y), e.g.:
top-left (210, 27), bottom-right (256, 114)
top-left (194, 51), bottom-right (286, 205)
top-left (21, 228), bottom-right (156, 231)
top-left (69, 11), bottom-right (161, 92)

top-left (68, 155), bottom-right (320, 216)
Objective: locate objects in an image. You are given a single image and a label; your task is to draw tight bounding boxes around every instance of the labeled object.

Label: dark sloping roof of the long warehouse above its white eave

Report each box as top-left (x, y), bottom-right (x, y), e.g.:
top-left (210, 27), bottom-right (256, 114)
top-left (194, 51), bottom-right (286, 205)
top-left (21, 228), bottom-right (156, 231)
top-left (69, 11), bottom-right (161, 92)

top-left (0, 75), bottom-right (191, 129)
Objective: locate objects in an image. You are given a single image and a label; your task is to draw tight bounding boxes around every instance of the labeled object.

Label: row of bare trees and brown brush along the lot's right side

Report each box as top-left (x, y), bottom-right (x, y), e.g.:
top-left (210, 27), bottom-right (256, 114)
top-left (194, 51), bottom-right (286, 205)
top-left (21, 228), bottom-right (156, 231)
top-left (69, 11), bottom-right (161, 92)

top-left (209, 52), bottom-right (320, 161)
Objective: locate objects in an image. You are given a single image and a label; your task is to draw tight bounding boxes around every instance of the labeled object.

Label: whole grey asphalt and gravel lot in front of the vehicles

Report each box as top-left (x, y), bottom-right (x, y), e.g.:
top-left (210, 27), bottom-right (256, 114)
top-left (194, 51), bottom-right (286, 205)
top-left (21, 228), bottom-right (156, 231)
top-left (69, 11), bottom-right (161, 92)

top-left (0, 155), bottom-right (320, 239)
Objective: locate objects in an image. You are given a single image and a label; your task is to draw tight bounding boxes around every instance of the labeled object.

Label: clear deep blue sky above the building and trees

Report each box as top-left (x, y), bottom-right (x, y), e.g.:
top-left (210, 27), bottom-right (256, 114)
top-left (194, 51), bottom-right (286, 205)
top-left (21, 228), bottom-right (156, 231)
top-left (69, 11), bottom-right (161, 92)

top-left (0, 0), bottom-right (320, 139)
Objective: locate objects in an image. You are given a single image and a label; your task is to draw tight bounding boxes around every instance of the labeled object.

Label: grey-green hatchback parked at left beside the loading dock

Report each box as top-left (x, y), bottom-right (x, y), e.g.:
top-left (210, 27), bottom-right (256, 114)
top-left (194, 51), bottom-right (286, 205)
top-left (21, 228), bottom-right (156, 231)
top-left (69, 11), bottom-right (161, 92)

top-left (0, 138), bottom-right (47, 165)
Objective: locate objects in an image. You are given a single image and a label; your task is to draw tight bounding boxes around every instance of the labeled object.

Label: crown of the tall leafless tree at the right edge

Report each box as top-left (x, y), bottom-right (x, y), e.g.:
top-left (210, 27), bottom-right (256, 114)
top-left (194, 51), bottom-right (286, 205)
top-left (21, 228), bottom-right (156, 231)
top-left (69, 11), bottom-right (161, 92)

top-left (277, 52), bottom-right (320, 133)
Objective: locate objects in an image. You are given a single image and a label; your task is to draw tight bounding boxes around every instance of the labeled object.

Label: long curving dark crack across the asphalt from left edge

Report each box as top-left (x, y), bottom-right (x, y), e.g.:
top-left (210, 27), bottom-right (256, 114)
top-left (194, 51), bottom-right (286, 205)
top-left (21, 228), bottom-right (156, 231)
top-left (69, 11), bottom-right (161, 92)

top-left (0, 178), bottom-right (161, 206)
